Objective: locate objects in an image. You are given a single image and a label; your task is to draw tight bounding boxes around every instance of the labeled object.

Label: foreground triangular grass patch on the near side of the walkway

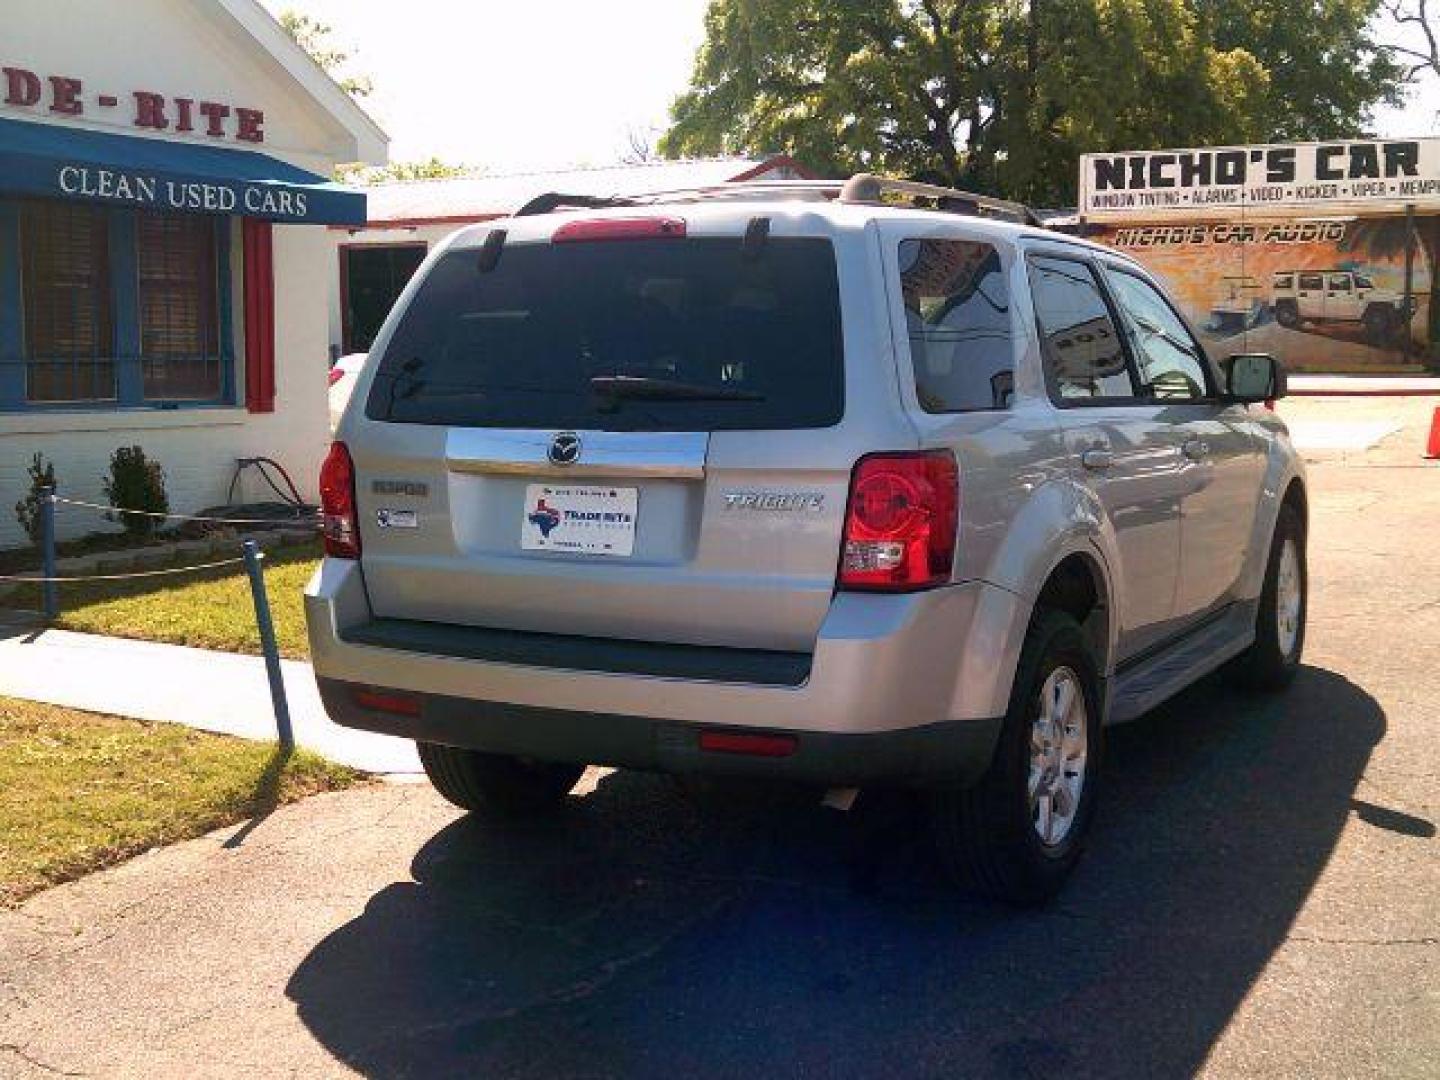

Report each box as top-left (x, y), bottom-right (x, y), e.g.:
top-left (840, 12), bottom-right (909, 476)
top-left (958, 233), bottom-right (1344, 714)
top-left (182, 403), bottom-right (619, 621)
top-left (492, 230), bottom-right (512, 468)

top-left (0, 697), bottom-right (363, 906)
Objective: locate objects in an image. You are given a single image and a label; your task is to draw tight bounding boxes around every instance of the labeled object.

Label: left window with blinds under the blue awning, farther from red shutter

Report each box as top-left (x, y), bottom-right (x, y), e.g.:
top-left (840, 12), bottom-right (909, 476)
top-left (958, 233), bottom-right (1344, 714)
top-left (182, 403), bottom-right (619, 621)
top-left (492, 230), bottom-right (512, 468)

top-left (20, 202), bottom-right (115, 402)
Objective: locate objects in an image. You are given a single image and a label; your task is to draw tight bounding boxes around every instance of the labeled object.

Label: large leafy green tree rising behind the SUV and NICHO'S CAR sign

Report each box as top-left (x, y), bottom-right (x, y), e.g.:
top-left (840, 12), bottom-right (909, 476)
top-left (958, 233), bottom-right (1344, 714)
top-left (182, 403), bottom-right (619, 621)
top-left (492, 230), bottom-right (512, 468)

top-left (660, 0), bottom-right (1400, 204)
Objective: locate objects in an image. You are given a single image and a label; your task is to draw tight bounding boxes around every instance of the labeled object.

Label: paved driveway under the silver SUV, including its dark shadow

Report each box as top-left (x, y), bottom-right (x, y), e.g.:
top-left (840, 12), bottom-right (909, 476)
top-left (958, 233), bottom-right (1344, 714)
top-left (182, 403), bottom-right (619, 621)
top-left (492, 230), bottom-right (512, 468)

top-left (0, 403), bottom-right (1440, 1077)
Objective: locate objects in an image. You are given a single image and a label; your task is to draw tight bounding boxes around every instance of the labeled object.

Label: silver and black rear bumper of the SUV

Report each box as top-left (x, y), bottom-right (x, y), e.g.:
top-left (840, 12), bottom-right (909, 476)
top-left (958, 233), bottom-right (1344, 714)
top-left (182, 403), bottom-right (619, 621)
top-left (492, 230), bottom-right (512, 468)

top-left (305, 559), bottom-right (1028, 782)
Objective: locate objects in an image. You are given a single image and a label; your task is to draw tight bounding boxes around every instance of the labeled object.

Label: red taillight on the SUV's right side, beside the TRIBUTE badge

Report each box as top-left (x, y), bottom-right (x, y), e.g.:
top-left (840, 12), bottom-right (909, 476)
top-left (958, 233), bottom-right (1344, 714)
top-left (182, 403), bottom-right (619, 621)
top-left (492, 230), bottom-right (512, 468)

top-left (838, 451), bottom-right (959, 592)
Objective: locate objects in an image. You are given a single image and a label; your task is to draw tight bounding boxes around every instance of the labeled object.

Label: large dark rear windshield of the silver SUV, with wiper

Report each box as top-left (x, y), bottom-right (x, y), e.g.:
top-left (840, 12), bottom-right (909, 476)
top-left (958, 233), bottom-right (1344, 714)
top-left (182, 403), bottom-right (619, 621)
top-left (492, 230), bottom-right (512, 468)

top-left (366, 238), bottom-right (845, 431)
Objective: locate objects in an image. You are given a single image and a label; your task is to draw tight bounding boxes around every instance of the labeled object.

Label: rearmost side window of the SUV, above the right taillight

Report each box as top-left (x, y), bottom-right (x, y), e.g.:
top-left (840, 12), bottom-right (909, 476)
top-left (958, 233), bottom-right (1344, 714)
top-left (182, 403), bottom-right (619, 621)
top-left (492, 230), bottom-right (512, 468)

top-left (899, 240), bottom-right (1015, 412)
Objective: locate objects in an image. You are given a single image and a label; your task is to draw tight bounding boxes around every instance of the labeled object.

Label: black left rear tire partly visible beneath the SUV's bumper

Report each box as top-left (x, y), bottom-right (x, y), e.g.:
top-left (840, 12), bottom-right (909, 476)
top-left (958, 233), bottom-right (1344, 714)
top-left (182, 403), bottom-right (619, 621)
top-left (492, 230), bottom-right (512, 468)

top-left (415, 743), bottom-right (585, 819)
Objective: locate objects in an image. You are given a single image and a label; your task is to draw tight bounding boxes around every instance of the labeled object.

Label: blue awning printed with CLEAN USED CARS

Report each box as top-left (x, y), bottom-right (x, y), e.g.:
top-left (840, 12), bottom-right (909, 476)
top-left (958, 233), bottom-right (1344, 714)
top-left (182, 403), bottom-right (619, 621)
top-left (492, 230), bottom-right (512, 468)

top-left (0, 120), bottom-right (366, 225)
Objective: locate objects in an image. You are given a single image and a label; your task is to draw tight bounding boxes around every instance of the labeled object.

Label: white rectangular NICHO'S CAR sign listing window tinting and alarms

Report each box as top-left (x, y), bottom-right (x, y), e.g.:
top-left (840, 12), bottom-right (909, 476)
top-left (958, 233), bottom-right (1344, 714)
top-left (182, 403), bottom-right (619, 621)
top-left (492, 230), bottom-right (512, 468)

top-left (1080, 138), bottom-right (1440, 222)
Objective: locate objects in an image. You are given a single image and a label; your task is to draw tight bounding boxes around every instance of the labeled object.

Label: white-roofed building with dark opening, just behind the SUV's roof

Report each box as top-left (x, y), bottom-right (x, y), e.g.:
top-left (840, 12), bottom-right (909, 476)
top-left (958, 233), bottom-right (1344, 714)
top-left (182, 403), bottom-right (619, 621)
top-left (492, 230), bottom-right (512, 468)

top-left (330, 156), bottom-right (811, 356)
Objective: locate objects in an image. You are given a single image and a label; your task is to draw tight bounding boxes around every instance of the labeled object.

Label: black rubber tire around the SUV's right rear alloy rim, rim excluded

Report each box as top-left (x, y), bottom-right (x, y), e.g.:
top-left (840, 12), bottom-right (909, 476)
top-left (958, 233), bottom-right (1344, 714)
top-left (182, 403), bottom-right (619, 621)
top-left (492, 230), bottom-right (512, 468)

top-left (930, 609), bottom-right (1103, 906)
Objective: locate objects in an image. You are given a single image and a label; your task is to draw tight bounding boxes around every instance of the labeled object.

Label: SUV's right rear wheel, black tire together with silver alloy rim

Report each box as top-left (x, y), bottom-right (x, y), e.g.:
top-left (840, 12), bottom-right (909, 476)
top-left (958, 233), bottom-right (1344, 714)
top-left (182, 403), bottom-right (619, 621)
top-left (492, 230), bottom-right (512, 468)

top-left (930, 611), bottom-right (1102, 904)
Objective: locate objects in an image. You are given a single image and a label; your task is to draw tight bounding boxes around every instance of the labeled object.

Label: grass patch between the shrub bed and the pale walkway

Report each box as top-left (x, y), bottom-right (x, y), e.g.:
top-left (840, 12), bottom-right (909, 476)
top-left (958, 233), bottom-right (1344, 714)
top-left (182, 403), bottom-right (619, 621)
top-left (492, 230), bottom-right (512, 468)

top-left (40, 544), bottom-right (320, 660)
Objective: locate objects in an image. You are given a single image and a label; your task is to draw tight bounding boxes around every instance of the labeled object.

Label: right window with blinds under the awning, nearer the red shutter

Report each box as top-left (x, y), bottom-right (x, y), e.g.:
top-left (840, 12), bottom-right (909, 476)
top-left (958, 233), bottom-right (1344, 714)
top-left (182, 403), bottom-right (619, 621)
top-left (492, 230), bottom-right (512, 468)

top-left (135, 213), bottom-right (223, 400)
